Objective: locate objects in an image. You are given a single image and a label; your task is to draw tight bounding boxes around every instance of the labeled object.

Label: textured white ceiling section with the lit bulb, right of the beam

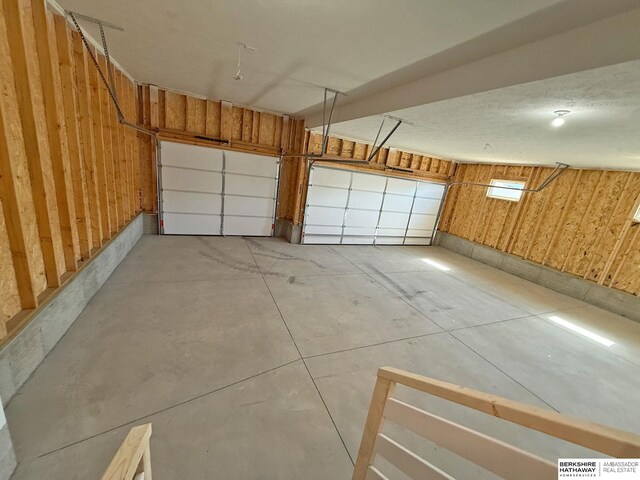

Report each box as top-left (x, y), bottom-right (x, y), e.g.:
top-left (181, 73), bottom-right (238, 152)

top-left (320, 61), bottom-right (640, 170)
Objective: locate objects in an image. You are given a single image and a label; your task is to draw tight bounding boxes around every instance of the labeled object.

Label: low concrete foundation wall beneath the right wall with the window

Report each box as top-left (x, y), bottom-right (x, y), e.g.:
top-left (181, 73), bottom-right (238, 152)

top-left (434, 232), bottom-right (640, 322)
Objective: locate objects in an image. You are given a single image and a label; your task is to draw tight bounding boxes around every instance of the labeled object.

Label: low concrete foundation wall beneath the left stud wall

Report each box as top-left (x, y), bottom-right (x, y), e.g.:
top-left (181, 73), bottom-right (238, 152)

top-left (0, 215), bottom-right (143, 404)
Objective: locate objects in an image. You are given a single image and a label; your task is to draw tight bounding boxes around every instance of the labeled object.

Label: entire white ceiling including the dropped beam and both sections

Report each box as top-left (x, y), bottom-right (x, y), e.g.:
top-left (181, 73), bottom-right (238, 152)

top-left (58, 0), bottom-right (640, 169)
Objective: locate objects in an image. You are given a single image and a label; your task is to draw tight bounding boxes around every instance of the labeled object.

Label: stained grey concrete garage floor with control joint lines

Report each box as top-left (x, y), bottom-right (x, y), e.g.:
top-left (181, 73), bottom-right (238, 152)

top-left (6, 236), bottom-right (640, 480)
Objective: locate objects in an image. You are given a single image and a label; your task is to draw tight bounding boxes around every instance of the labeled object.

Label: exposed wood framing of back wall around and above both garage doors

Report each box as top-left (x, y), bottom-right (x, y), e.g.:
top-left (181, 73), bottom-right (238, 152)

top-left (137, 89), bottom-right (455, 225)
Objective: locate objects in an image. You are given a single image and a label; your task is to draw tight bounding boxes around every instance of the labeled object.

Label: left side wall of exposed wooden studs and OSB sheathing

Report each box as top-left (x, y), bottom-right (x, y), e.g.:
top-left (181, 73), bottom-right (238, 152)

top-left (0, 0), bottom-right (140, 342)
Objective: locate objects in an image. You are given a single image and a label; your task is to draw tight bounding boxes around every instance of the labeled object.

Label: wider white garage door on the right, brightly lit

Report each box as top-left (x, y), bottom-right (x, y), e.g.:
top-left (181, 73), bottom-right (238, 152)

top-left (302, 166), bottom-right (444, 245)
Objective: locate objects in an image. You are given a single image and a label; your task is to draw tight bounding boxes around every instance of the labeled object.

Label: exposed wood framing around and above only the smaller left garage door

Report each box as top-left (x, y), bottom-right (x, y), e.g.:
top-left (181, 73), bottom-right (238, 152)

top-left (136, 85), bottom-right (304, 219)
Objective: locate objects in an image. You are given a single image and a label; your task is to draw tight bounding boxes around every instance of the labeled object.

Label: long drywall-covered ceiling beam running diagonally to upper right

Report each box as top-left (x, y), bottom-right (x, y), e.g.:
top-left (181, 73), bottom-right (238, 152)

top-left (298, 0), bottom-right (640, 128)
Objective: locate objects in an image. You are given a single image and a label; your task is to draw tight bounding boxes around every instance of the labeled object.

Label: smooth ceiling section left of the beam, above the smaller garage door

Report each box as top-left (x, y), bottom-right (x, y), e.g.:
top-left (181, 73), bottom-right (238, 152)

top-left (58, 0), bottom-right (564, 113)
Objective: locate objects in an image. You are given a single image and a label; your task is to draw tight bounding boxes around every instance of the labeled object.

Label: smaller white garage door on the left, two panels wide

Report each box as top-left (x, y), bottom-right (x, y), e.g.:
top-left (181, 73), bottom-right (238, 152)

top-left (160, 141), bottom-right (280, 236)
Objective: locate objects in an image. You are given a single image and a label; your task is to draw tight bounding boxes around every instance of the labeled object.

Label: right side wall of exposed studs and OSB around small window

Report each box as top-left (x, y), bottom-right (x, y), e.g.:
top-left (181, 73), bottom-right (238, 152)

top-left (440, 164), bottom-right (640, 295)
